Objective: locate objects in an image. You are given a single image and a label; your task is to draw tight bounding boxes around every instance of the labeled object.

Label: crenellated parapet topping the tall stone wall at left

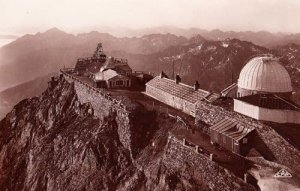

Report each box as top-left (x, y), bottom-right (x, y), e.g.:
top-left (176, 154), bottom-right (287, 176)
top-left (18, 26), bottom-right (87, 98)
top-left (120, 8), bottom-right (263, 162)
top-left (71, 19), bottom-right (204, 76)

top-left (60, 68), bottom-right (127, 110)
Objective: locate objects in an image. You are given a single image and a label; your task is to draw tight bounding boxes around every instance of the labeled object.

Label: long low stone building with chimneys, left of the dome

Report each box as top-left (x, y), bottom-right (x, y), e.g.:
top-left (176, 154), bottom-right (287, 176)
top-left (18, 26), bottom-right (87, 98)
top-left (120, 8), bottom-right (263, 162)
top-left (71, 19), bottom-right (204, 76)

top-left (146, 72), bottom-right (219, 116)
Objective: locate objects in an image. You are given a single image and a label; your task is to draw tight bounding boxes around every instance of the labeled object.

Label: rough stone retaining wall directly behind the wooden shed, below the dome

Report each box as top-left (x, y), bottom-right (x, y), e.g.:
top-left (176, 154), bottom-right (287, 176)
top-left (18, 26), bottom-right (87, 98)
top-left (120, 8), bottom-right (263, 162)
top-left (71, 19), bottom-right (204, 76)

top-left (195, 101), bottom-right (300, 172)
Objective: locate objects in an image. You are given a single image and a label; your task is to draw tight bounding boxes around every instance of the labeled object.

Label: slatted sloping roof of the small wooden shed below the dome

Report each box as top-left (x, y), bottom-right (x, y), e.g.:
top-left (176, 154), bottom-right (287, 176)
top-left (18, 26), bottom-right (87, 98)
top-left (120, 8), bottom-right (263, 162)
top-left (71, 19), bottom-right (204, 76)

top-left (210, 118), bottom-right (254, 141)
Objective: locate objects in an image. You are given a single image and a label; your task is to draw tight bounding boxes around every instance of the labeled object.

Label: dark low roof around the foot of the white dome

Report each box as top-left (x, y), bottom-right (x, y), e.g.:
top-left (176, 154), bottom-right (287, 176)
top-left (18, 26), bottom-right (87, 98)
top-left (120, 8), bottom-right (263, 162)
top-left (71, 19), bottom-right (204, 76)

top-left (237, 94), bottom-right (300, 111)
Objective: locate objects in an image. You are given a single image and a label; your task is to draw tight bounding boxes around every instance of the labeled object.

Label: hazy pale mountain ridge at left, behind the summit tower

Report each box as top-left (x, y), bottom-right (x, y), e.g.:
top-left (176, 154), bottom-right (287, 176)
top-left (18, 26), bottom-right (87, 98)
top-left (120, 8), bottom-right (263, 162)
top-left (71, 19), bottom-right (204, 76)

top-left (0, 28), bottom-right (188, 90)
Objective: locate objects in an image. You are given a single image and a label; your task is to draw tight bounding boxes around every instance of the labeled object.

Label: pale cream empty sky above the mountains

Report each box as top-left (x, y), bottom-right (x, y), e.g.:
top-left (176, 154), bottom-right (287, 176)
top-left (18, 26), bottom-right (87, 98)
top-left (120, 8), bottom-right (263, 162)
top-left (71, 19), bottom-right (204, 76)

top-left (0, 0), bottom-right (300, 35)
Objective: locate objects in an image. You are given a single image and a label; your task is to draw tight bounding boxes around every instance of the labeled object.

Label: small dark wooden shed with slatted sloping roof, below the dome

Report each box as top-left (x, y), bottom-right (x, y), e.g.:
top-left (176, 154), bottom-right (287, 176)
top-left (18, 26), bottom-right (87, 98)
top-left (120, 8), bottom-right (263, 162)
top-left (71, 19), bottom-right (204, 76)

top-left (209, 118), bottom-right (254, 154)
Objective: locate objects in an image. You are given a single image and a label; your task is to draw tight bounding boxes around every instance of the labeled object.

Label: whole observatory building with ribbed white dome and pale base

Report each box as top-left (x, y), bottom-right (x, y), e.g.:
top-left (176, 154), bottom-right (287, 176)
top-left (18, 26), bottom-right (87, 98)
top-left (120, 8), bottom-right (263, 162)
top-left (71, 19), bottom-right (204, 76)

top-left (234, 55), bottom-right (300, 124)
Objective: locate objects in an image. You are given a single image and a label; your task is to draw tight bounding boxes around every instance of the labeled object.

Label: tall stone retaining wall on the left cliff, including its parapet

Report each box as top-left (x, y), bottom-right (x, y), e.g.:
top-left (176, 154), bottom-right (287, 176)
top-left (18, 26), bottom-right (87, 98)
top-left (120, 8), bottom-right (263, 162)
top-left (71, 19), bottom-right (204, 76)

top-left (61, 71), bottom-right (142, 157)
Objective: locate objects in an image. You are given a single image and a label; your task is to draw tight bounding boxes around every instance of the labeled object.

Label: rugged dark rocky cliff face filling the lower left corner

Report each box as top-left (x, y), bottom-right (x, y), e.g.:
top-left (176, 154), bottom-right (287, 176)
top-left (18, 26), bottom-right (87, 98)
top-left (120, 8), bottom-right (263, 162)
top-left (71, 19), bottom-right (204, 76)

top-left (0, 77), bottom-right (136, 190)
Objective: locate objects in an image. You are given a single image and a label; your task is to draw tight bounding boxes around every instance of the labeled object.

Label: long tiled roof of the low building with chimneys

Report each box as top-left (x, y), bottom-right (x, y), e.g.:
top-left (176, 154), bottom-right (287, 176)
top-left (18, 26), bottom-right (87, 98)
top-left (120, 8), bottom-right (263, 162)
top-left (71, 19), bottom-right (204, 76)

top-left (146, 76), bottom-right (219, 103)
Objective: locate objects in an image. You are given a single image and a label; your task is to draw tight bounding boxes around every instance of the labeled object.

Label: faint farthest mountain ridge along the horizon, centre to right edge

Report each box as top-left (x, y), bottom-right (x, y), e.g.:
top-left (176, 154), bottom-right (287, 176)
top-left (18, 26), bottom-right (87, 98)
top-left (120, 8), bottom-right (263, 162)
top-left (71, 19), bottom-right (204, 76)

top-left (78, 26), bottom-right (300, 48)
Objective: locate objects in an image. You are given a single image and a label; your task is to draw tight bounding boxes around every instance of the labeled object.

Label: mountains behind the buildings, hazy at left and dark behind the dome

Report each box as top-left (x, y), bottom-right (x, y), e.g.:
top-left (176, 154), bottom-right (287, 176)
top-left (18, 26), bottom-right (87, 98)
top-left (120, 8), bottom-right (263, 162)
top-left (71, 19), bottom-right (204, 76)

top-left (0, 28), bottom-right (300, 115)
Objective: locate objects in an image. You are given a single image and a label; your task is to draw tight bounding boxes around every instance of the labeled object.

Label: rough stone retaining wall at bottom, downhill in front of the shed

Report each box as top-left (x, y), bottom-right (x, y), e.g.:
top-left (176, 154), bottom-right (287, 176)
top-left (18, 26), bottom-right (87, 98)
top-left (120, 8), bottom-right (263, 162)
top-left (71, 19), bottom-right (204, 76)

top-left (162, 134), bottom-right (256, 191)
